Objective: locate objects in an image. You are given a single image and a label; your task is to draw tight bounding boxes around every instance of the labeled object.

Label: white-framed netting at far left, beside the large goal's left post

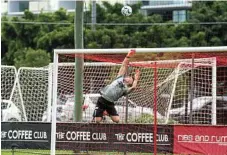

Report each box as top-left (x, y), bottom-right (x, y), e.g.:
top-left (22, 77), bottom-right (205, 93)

top-left (1, 66), bottom-right (52, 122)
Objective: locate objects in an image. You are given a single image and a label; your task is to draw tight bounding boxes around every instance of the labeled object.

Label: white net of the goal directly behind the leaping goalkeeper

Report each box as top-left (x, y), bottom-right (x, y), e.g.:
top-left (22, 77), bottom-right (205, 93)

top-left (51, 56), bottom-right (215, 124)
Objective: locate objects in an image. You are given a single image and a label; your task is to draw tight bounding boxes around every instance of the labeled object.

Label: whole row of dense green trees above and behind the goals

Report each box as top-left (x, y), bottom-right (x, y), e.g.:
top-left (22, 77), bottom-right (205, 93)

top-left (1, 1), bottom-right (227, 65)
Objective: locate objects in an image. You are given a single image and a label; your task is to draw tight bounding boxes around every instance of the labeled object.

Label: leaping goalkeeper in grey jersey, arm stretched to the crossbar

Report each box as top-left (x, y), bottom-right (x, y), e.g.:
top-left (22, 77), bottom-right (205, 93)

top-left (93, 50), bottom-right (140, 123)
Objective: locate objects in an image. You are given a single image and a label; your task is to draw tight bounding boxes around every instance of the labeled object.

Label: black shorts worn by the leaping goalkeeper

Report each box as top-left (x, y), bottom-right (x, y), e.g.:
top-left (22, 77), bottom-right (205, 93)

top-left (93, 97), bottom-right (119, 117)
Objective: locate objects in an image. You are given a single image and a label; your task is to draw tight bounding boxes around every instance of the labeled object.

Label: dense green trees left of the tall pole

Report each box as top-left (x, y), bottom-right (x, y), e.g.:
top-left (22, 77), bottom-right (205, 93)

top-left (1, 9), bottom-right (74, 65)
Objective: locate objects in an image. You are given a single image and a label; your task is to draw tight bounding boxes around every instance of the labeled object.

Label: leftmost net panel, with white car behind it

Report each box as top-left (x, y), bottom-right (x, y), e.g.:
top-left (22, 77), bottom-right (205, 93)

top-left (1, 66), bottom-right (27, 121)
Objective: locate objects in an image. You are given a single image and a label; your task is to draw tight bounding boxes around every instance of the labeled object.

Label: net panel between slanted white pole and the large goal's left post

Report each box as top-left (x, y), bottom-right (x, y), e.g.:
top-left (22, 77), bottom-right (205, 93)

top-left (18, 67), bottom-right (52, 121)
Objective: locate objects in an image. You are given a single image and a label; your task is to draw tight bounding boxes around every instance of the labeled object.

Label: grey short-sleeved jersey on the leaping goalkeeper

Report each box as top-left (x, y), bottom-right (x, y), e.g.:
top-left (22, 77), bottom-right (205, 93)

top-left (101, 76), bottom-right (128, 102)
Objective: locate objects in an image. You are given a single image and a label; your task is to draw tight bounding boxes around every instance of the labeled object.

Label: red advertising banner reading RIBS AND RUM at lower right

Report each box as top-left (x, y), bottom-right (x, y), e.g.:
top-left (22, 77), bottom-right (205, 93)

top-left (173, 125), bottom-right (227, 155)
